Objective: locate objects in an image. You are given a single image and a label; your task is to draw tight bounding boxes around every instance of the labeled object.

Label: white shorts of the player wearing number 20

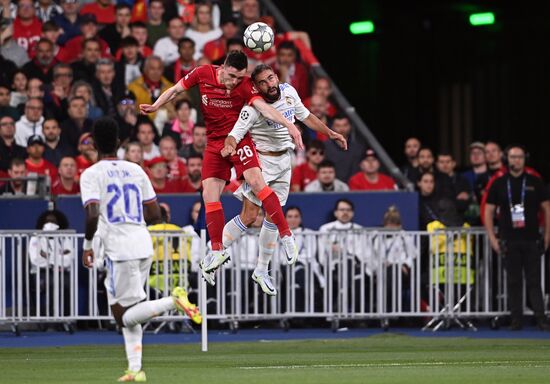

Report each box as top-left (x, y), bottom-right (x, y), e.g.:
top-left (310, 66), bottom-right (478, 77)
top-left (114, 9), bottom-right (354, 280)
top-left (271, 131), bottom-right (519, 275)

top-left (105, 256), bottom-right (153, 307)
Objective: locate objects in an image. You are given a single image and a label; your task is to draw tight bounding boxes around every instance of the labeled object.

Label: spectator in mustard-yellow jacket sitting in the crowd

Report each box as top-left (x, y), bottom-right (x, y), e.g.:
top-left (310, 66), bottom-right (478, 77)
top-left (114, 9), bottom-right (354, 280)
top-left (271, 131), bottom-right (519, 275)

top-left (128, 56), bottom-right (173, 120)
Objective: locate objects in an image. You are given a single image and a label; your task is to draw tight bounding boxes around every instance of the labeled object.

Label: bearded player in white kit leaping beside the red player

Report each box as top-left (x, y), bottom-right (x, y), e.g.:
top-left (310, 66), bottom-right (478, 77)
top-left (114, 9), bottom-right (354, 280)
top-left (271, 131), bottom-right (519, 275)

top-left (218, 64), bottom-right (347, 296)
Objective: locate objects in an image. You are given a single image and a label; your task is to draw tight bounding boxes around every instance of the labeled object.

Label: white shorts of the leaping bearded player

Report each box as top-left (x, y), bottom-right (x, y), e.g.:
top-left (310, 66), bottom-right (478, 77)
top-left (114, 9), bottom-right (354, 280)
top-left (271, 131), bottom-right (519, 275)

top-left (233, 150), bottom-right (292, 207)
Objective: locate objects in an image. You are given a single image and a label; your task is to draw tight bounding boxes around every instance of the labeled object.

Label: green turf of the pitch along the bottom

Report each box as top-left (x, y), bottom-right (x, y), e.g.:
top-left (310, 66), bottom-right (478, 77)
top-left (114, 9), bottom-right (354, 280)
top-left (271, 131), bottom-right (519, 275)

top-left (0, 334), bottom-right (550, 384)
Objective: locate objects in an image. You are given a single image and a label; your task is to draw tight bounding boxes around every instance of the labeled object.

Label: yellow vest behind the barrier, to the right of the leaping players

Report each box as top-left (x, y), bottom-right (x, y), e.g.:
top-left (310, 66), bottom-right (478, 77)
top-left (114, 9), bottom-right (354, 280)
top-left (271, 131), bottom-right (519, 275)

top-left (427, 220), bottom-right (475, 284)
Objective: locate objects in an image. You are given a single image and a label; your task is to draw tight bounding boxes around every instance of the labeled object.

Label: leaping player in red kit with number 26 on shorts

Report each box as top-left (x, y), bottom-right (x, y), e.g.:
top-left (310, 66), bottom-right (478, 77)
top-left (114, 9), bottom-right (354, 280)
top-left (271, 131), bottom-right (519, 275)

top-left (140, 51), bottom-right (303, 285)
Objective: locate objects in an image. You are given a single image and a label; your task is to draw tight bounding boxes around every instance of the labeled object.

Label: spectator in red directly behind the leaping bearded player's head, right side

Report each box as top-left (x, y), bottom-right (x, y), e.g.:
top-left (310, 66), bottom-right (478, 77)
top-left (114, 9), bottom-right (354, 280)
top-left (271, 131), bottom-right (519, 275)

top-left (274, 41), bottom-right (309, 99)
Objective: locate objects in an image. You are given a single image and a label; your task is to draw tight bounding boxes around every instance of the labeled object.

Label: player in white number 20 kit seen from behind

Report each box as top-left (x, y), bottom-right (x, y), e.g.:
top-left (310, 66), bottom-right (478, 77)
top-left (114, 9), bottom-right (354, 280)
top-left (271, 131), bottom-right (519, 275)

top-left (80, 118), bottom-right (202, 382)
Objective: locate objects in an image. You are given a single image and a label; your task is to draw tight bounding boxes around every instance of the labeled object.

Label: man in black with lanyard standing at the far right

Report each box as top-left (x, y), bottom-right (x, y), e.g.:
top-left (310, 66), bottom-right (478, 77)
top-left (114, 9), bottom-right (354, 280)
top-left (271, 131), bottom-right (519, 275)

top-left (485, 145), bottom-right (550, 331)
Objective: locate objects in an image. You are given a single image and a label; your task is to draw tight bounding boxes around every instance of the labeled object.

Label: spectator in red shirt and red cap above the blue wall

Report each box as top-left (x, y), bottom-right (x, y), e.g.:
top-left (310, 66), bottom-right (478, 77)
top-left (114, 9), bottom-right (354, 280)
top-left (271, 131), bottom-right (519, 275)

top-left (348, 149), bottom-right (397, 191)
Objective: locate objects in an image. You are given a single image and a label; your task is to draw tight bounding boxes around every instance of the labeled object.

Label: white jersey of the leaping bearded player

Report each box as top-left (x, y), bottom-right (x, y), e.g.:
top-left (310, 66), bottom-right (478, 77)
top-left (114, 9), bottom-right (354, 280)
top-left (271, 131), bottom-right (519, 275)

top-left (229, 83), bottom-right (310, 152)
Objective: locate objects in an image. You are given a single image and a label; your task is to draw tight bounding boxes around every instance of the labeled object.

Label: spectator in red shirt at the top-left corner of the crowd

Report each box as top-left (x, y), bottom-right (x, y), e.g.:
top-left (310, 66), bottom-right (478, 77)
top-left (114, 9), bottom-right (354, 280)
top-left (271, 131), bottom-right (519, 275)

top-left (12, 0), bottom-right (42, 52)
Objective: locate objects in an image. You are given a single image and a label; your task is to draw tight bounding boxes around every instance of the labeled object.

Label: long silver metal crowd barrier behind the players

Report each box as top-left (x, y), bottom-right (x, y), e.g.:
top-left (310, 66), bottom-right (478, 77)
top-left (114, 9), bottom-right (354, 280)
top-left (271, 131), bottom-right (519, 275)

top-left (0, 228), bottom-right (546, 329)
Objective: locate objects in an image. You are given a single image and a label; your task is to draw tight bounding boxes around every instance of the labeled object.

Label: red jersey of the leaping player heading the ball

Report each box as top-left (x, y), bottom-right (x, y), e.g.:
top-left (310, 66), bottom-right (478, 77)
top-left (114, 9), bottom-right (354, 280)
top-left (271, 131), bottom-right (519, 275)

top-left (180, 65), bottom-right (261, 152)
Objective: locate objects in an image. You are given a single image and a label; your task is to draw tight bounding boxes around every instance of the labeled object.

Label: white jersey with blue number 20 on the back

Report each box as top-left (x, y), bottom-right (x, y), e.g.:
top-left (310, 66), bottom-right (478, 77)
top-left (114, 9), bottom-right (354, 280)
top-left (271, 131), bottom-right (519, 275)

top-left (80, 159), bottom-right (156, 261)
